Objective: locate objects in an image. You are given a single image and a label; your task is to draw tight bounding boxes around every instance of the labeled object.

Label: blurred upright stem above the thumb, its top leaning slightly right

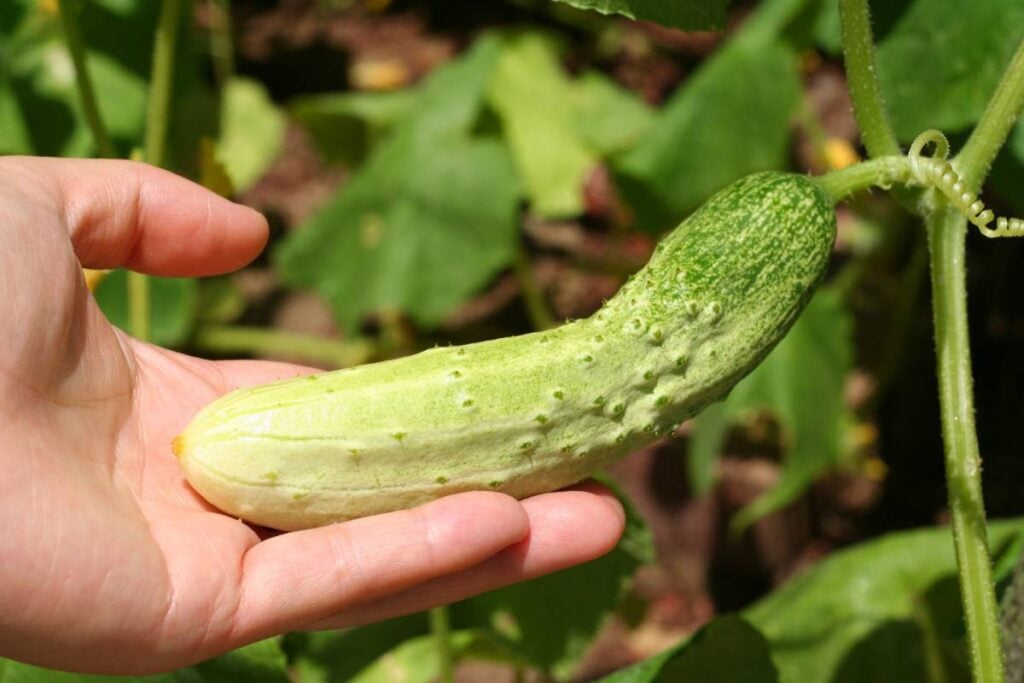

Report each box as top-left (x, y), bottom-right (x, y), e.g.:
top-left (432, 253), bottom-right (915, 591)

top-left (145, 0), bottom-right (181, 166)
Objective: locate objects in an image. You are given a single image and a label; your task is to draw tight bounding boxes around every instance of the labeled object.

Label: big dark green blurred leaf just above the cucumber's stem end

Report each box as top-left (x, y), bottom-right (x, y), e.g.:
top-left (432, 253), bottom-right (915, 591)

top-left (613, 40), bottom-right (800, 231)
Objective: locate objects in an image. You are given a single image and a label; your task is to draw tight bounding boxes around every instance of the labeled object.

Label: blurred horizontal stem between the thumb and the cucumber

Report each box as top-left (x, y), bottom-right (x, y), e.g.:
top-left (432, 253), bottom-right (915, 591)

top-left (191, 326), bottom-right (375, 368)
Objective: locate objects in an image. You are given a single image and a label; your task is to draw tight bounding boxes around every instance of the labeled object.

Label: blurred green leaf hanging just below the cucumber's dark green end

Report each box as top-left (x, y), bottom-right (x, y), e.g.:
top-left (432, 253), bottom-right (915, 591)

top-left (689, 289), bottom-right (853, 526)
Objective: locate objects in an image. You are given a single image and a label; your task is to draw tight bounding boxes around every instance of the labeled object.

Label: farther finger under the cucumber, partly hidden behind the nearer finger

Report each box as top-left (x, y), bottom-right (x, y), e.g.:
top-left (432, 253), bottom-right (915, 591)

top-left (307, 483), bottom-right (626, 631)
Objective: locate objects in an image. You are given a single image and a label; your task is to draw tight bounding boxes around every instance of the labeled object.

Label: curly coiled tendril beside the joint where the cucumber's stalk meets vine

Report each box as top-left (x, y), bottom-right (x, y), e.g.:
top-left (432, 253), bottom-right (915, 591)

top-left (906, 129), bottom-right (1024, 238)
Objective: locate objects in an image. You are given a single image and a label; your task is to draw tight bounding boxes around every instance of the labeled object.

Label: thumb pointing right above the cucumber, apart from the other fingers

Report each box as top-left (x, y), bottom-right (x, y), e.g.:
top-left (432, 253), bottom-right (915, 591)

top-left (24, 159), bottom-right (267, 275)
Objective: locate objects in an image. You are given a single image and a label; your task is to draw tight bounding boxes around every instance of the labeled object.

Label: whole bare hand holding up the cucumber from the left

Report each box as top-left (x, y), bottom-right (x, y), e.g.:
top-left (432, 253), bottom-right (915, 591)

top-left (0, 158), bottom-right (625, 674)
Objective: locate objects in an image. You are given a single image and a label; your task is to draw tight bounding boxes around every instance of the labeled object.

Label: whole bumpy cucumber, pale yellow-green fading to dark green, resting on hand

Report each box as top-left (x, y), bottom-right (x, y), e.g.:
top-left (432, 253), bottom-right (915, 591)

top-left (174, 172), bottom-right (836, 529)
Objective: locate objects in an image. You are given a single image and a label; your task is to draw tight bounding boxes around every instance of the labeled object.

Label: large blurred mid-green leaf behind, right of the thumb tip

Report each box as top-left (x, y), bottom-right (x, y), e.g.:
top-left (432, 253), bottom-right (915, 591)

top-left (275, 38), bottom-right (520, 330)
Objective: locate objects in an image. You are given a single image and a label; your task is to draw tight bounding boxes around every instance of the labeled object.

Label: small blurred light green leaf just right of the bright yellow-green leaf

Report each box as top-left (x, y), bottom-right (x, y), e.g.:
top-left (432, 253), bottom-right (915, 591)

top-left (570, 71), bottom-right (654, 157)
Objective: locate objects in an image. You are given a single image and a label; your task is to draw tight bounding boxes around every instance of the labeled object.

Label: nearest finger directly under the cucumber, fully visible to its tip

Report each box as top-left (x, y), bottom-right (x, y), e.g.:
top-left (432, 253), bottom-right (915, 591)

top-left (232, 492), bottom-right (529, 643)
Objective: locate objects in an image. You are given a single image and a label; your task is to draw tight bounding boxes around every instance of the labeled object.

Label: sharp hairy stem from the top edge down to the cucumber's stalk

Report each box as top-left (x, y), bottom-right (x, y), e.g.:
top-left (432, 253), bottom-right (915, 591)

top-left (839, 0), bottom-right (900, 157)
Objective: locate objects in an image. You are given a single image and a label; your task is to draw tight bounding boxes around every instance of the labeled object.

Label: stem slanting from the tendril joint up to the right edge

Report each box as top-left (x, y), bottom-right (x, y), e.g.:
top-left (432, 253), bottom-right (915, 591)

top-left (953, 40), bottom-right (1024, 193)
